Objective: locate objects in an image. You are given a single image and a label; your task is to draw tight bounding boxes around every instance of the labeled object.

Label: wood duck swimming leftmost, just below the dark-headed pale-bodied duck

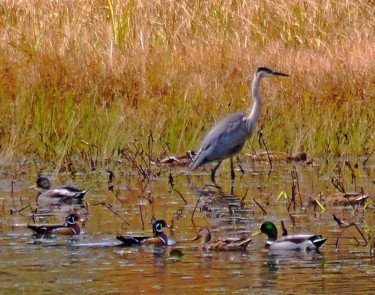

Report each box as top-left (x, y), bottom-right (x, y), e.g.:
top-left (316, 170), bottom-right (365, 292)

top-left (27, 213), bottom-right (81, 239)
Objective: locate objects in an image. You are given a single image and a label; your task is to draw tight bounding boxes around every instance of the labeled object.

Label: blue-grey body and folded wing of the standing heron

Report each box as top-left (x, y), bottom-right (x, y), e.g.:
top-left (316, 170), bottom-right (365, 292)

top-left (195, 113), bottom-right (250, 167)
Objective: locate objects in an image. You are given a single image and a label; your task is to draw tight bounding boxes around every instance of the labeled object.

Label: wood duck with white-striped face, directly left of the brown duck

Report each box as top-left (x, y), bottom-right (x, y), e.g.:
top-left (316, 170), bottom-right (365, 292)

top-left (116, 218), bottom-right (169, 246)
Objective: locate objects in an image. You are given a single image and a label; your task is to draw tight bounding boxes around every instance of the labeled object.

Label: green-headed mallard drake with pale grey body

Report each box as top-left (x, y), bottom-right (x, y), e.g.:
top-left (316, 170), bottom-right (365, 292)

top-left (260, 221), bottom-right (327, 251)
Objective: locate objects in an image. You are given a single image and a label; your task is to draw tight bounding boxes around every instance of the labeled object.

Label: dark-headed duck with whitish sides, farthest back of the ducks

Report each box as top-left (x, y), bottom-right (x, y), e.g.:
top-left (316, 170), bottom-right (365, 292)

top-left (36, 177), bottom-right (87, 207)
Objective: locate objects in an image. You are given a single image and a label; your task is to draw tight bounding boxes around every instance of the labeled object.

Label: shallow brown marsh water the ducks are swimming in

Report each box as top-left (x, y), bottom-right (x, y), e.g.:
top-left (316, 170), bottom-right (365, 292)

top-left (0, 160), bottom-right (375, 294)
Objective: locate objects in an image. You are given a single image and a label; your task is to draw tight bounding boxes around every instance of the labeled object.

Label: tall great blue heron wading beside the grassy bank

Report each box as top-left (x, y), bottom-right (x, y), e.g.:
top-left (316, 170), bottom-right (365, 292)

top-left (190, 67), bottom-right (288, 181)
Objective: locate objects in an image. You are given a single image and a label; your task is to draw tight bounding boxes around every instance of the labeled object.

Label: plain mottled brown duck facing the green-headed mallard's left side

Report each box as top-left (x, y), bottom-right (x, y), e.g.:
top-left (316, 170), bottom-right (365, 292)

top-left (193, 227), bottom-right (252, 251)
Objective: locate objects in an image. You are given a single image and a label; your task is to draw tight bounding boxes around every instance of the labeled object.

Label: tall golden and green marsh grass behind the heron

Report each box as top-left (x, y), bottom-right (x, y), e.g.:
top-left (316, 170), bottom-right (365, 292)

top-left (0, 0), bottom-right (375, 168)
